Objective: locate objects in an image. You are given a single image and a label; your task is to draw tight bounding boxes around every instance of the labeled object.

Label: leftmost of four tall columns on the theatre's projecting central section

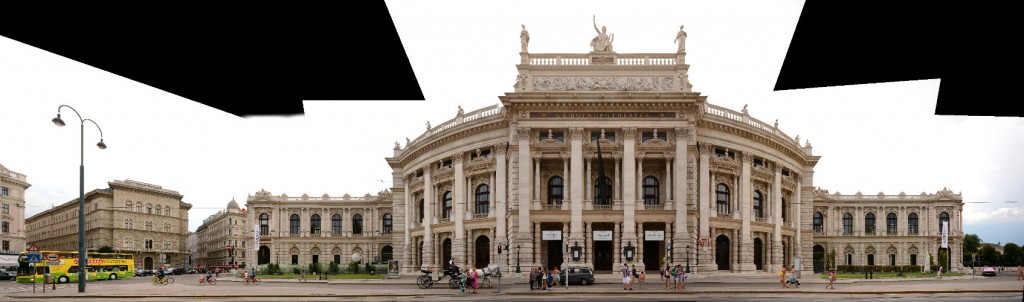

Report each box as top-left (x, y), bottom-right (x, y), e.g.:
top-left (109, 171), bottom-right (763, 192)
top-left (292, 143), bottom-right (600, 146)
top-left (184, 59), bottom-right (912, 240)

top-left (515, 128), bottom-right (536, 267)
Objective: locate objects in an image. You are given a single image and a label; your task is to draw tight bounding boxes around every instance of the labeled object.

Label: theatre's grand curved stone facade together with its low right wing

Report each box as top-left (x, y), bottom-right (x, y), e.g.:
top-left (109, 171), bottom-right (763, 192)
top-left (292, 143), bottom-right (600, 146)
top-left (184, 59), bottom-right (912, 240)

top-left (386, 24), bottom-right (963, 273)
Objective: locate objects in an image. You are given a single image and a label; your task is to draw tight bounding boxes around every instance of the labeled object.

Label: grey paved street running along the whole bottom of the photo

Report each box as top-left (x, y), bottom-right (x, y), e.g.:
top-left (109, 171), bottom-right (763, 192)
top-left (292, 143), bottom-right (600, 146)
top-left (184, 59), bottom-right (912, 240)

top-left (0, 274), bottom-right (1024, 301)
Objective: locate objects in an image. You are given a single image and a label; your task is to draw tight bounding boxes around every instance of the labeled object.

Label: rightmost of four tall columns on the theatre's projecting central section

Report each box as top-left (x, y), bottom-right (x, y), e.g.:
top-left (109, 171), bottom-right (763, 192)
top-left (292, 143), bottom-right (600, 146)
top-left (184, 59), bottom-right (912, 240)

top-left (665, 127), bottom-right (688, 264)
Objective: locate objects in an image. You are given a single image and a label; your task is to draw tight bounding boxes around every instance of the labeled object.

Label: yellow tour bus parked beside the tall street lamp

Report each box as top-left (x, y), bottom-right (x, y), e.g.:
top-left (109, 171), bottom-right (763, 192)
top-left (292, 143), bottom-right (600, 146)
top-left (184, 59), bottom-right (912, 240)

top-left (17, 251), bottom-right (135, 284)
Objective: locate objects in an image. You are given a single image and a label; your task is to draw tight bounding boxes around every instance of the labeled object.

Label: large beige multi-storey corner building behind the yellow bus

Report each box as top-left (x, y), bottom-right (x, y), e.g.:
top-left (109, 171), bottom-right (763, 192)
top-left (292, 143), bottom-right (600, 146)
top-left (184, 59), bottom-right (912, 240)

top-left (26, 180), bottom-right (191, 269)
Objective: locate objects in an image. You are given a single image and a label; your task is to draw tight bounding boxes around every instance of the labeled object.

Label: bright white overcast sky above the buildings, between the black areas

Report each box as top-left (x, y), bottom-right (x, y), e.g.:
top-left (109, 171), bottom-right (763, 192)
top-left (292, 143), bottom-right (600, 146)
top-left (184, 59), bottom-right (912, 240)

top-left (0, 0), bottom-right (1024, 244)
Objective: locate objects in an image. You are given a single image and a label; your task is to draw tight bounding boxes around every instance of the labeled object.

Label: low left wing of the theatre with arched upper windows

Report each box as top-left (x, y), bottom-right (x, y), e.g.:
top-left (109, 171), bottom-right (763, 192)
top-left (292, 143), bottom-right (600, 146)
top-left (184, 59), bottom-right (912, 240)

top-left (242, 189), bottom-right (397, 266)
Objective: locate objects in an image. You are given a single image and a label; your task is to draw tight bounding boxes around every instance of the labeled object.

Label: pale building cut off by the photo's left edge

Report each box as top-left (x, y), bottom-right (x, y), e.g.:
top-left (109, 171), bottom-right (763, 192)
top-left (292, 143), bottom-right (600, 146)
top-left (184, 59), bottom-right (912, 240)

top-left (0, 165), bottom-right (32, 254)
